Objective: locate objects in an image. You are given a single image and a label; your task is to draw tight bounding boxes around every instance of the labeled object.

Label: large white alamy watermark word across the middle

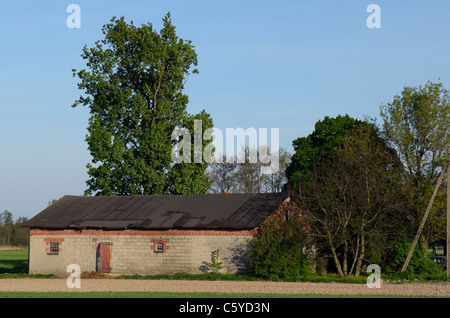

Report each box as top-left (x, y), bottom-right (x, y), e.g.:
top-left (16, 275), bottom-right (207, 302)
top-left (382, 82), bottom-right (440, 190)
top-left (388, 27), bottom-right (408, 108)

top-left (171, 119), bottom-right (280, 174)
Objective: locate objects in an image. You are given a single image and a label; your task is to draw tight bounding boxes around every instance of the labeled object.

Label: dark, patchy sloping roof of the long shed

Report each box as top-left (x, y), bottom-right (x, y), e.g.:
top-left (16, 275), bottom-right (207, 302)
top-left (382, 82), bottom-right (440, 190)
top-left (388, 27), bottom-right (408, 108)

top-left (25, 193), bottom-right (288, 229)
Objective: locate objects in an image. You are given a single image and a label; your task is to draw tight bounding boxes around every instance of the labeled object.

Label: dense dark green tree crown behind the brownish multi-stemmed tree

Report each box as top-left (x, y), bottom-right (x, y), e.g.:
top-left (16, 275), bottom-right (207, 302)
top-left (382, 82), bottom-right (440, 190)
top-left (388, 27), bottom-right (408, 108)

top-left (286, 115), bottom-right (363, 192)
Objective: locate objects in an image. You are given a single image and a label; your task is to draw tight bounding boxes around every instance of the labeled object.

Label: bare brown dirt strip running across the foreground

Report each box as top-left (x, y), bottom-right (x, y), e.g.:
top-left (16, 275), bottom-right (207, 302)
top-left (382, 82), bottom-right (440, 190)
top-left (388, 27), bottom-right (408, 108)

top-left (0, 278), bottom-right (450, 297)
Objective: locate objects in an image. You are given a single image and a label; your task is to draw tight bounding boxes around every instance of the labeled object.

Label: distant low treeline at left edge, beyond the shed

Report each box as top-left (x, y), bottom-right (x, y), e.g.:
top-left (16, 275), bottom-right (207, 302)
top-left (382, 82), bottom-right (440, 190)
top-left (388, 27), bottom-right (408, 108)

top-left (0, 210), bottom-right (29, 246)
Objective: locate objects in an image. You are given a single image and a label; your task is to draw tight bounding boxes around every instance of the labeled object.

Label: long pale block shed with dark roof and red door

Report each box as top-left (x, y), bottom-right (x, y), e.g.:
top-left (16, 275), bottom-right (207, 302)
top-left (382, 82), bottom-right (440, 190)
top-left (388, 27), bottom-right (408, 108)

top-left (25, 193), bottom-right (290, 274)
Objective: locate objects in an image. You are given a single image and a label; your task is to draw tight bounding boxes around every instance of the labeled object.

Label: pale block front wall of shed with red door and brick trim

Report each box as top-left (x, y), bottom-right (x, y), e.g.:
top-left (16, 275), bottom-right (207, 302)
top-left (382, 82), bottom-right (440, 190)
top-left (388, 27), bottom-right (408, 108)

top-left (29, 229), bottom-right (253, 275)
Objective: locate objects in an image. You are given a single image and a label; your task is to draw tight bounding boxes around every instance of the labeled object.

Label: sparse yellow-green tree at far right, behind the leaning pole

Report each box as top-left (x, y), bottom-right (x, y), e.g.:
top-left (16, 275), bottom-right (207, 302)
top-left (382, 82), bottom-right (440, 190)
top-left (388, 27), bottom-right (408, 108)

top-left (380, 82), bottom-right (450, 255)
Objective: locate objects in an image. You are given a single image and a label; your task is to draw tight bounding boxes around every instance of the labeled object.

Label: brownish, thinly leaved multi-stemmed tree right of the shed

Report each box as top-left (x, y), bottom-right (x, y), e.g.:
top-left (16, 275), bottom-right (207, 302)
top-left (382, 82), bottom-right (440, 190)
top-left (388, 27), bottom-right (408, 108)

top-left (293, 124), bottom-right (407, 276)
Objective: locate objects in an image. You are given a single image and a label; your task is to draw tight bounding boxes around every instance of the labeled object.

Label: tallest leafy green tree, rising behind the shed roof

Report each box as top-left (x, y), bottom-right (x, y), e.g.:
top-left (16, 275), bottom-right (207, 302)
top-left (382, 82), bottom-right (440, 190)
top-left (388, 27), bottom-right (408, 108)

top-left (73, 13), bottom-right (212, 195)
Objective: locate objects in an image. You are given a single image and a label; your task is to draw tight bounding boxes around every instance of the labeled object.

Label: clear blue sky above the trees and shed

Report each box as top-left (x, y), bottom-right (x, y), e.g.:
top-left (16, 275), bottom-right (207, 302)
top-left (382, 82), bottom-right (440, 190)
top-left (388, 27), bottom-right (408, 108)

top-left (0, 0), bottom-right (450, 218)
